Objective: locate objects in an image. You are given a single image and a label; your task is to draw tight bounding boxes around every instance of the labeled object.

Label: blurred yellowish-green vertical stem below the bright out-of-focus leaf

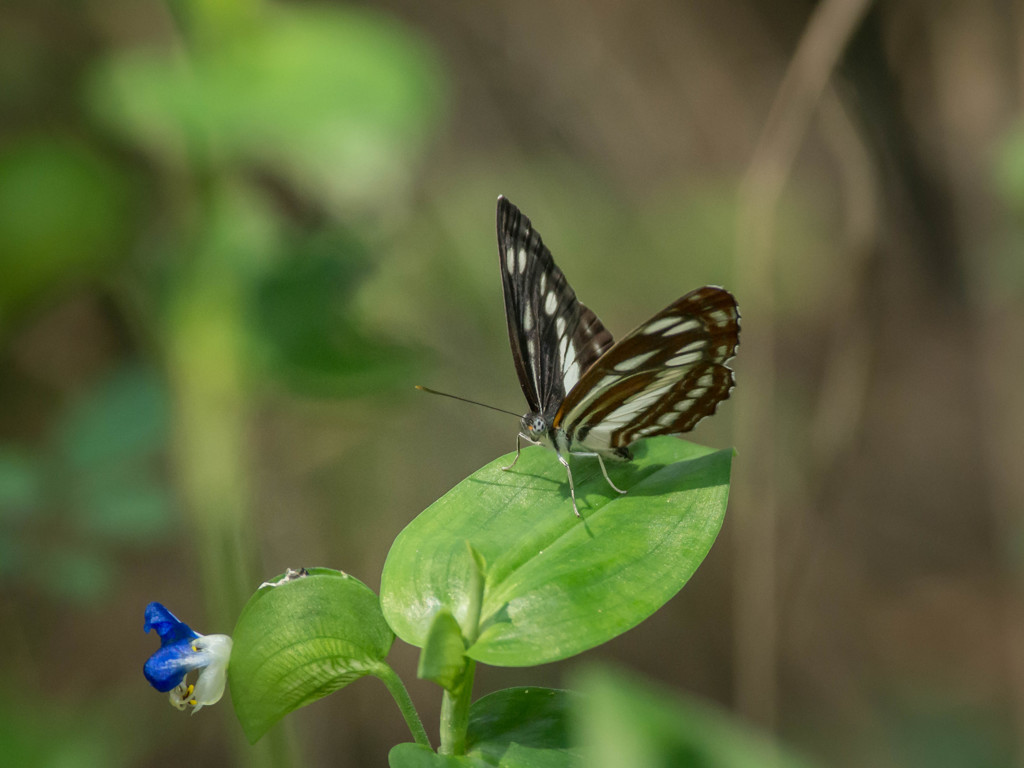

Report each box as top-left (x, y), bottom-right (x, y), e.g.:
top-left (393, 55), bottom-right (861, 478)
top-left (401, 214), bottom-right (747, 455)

top-left (165, 187), bottom-right (258, 627)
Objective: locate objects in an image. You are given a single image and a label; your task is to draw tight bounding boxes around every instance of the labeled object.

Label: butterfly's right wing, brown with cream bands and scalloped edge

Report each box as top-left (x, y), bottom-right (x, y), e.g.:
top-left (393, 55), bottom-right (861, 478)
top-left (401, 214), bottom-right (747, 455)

top-left (553, 286), bottom-right (739, 451)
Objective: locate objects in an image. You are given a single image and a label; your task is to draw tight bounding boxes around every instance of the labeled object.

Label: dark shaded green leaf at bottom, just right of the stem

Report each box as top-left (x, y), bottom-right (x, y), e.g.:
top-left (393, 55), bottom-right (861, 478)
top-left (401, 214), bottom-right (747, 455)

top-left (466, 687), bottom-right (581, 768)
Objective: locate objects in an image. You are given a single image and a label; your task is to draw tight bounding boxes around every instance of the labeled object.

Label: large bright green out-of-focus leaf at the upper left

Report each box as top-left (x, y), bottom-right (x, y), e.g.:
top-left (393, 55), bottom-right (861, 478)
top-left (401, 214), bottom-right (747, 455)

top-left (83, 4), bottom-right (442, 212)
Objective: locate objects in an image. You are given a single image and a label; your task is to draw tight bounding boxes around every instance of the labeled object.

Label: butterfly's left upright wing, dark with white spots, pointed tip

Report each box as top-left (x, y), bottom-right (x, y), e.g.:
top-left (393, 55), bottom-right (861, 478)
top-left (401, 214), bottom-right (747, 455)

top-left (498, 198), bottom-right (612, 416)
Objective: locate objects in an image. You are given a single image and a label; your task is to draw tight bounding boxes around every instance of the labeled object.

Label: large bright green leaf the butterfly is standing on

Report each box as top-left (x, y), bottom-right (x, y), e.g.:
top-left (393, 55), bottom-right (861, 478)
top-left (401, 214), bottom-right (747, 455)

top-left (381, 437), bottom-right (732, 667)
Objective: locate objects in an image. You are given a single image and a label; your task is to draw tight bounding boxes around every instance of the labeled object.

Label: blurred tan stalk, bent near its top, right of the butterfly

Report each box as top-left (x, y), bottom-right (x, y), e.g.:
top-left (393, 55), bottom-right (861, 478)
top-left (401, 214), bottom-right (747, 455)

top-left (734, 0), bottom-right (870, 727)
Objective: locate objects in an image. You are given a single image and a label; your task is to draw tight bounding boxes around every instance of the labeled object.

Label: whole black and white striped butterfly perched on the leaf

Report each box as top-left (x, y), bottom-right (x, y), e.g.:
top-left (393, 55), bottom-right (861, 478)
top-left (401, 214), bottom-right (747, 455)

top-left (498, 197), bottom-right (739, 517)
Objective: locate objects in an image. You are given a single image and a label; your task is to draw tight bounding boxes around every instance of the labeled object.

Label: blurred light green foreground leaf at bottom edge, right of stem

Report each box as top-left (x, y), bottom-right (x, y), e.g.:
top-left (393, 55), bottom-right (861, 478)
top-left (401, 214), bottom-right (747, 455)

top-left (572, 670), bottom-right (811, 768)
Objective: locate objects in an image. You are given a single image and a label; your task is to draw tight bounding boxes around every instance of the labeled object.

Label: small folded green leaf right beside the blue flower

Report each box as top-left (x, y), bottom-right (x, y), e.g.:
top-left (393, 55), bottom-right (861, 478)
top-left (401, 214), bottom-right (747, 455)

top-left (227, 568), bottom-right (394, 743)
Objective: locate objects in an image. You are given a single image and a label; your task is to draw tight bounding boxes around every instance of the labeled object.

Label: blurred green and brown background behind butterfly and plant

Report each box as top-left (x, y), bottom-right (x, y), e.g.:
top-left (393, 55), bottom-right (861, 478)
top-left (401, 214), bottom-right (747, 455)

top-left (0, 0), bottom-right (1024, 768)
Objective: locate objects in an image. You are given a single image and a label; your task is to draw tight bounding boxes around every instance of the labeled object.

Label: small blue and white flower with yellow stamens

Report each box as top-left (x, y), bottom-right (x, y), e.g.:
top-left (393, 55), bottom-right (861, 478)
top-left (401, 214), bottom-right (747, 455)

top-left (142, 602), bottom-right (231, 713)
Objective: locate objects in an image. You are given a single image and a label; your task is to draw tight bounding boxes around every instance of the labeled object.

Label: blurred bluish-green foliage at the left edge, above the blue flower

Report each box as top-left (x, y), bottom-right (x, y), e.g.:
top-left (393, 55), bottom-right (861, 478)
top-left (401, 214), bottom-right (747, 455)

top-left (0, 366), bottom-right (171, 602)
